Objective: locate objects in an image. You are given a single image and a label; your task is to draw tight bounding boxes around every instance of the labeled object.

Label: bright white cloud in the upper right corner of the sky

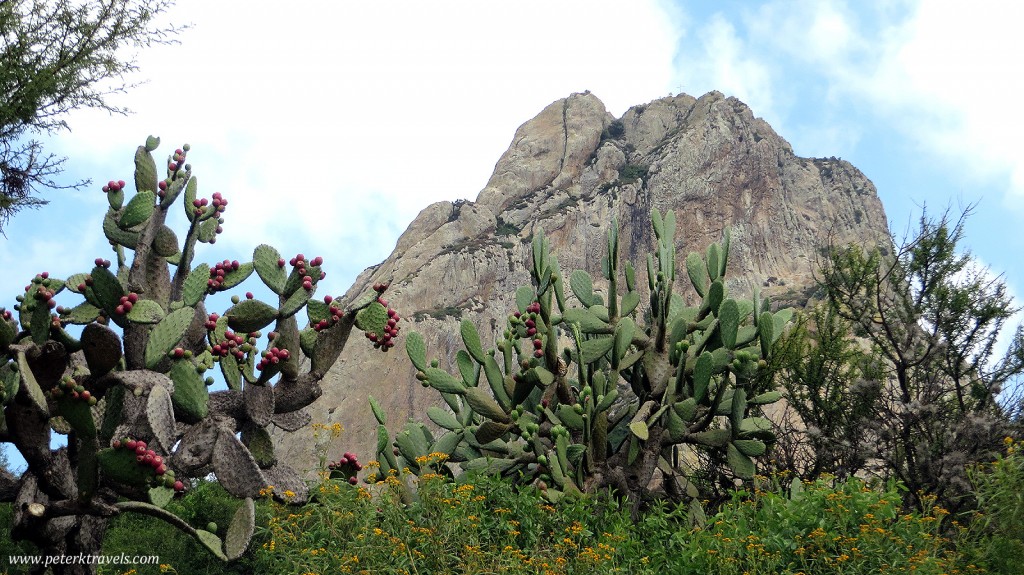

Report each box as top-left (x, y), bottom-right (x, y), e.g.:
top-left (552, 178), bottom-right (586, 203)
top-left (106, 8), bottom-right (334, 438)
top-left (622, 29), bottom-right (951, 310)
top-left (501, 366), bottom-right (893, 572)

top-left (865, 1), bottom-right (1024, 201)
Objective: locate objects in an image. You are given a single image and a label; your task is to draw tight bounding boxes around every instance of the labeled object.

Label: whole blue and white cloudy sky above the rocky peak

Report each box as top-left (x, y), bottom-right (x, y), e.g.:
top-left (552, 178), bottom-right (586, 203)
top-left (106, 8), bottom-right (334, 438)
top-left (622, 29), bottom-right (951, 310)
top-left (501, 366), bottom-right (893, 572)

top-left (0, 0), bottom-right (1024, 466)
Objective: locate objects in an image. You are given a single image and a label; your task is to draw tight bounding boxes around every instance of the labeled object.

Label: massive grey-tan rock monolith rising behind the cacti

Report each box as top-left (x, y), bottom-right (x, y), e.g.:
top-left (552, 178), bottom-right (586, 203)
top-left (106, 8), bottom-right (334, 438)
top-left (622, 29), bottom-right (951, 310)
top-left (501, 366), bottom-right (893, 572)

top-left (276, 92), bottom-right (888, 469)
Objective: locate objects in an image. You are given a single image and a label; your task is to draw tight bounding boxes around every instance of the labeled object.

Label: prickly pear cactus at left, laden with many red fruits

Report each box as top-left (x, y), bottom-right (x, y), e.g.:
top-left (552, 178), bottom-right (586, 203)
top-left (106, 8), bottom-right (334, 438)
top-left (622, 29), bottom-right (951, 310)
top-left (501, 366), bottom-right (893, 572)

top-left (0, 137), bottom-right (400, 559)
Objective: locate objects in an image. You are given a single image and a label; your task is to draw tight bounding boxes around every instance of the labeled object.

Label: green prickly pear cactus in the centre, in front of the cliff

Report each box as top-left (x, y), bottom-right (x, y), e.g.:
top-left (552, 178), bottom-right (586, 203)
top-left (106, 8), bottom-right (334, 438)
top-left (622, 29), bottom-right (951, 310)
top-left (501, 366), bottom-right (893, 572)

top-left (372, 211), bottom-right (792, 509)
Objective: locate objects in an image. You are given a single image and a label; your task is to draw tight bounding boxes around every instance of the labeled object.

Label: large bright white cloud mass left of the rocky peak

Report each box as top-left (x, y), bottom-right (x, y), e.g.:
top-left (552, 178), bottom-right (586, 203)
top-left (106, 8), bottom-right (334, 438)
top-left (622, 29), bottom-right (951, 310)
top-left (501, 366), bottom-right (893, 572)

top-left (25, 0), bottom-right (678, 300)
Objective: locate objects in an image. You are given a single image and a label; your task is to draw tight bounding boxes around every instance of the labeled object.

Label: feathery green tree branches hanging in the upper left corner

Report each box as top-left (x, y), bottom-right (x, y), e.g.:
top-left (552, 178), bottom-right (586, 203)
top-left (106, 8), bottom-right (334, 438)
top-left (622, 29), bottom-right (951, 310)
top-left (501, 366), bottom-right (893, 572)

top-left (0, 0), bottom-right (178, 231)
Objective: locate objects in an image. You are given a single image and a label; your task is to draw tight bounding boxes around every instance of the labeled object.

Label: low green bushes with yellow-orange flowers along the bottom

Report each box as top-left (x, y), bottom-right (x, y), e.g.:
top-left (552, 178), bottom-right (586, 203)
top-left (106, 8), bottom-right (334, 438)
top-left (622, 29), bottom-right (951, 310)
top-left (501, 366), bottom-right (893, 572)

top-left (243, 468), bottom-right (978, 575)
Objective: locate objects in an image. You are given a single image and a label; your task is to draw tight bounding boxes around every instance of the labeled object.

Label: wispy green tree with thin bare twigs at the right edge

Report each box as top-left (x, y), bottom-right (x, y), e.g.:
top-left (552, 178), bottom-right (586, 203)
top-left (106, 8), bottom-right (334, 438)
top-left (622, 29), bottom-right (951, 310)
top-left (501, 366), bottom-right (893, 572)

top-left (820, 206), bottom-right (1024, 511)
